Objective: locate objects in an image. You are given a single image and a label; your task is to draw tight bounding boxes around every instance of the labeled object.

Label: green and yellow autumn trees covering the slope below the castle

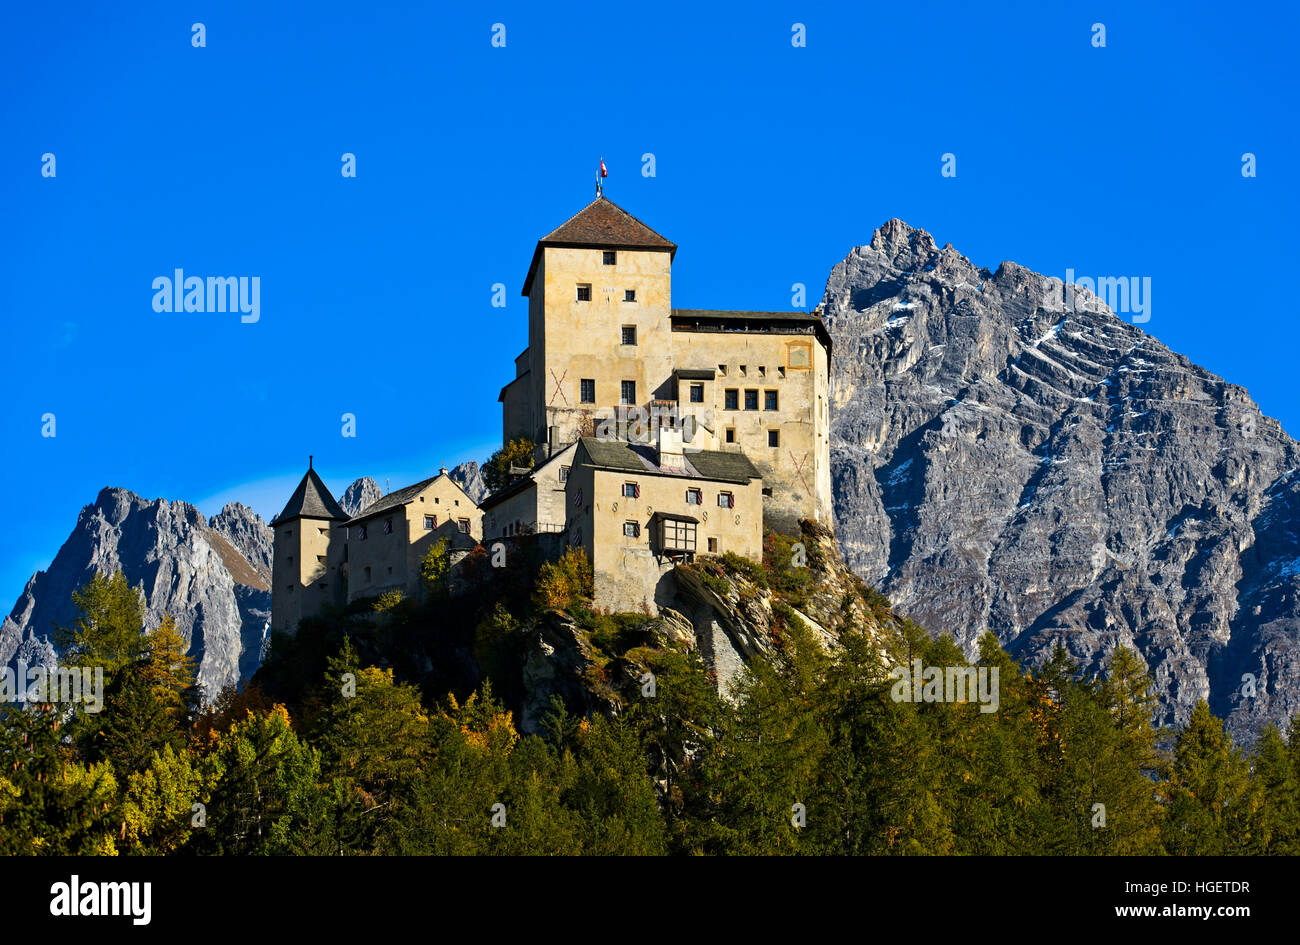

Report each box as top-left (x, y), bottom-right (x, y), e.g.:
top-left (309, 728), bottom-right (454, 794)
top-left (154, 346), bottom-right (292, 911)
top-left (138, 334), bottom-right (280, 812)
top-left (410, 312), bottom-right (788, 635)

top-left (12, 569), bottom-right (1300, 855)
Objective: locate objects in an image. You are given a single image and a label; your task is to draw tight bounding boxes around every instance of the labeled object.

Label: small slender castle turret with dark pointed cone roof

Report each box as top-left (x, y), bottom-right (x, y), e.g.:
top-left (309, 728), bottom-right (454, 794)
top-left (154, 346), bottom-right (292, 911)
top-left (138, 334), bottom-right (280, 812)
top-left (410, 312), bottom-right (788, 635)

top-left (270, 459), bottom-right (347, 633)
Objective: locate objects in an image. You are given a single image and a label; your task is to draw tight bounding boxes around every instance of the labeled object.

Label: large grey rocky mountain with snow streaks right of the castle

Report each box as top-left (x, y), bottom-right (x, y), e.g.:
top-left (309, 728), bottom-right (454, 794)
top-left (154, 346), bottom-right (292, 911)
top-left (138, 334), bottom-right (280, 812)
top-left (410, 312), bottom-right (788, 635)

top-left (823, 220), bottom-right (1300, 737)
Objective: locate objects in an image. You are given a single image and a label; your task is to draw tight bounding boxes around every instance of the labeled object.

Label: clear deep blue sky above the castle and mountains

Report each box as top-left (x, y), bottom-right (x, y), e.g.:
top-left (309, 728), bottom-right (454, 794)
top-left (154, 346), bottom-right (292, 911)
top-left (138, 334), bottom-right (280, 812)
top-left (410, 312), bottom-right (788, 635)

top-left (0, 1), bottom-right (1300, 610)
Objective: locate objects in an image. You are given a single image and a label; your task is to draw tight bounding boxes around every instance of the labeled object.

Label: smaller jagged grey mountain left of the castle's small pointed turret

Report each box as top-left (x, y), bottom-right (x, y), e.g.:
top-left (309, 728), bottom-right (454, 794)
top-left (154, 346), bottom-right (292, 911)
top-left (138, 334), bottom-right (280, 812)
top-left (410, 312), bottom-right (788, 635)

top-left (0, 489), bottom-right (270, 699)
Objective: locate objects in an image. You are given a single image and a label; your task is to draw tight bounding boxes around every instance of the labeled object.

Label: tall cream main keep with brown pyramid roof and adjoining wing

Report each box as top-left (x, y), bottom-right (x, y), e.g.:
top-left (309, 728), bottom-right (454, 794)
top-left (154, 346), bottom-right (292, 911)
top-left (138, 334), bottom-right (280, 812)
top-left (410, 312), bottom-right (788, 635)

top-left (499, 196), bottom-right (833, 532)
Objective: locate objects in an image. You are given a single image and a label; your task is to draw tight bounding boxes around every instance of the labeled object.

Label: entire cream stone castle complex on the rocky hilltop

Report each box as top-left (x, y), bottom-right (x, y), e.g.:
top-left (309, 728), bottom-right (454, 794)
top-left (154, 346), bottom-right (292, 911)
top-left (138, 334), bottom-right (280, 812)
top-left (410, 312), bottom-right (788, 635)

top-left (272, 189), bottom-right (831, 632)
